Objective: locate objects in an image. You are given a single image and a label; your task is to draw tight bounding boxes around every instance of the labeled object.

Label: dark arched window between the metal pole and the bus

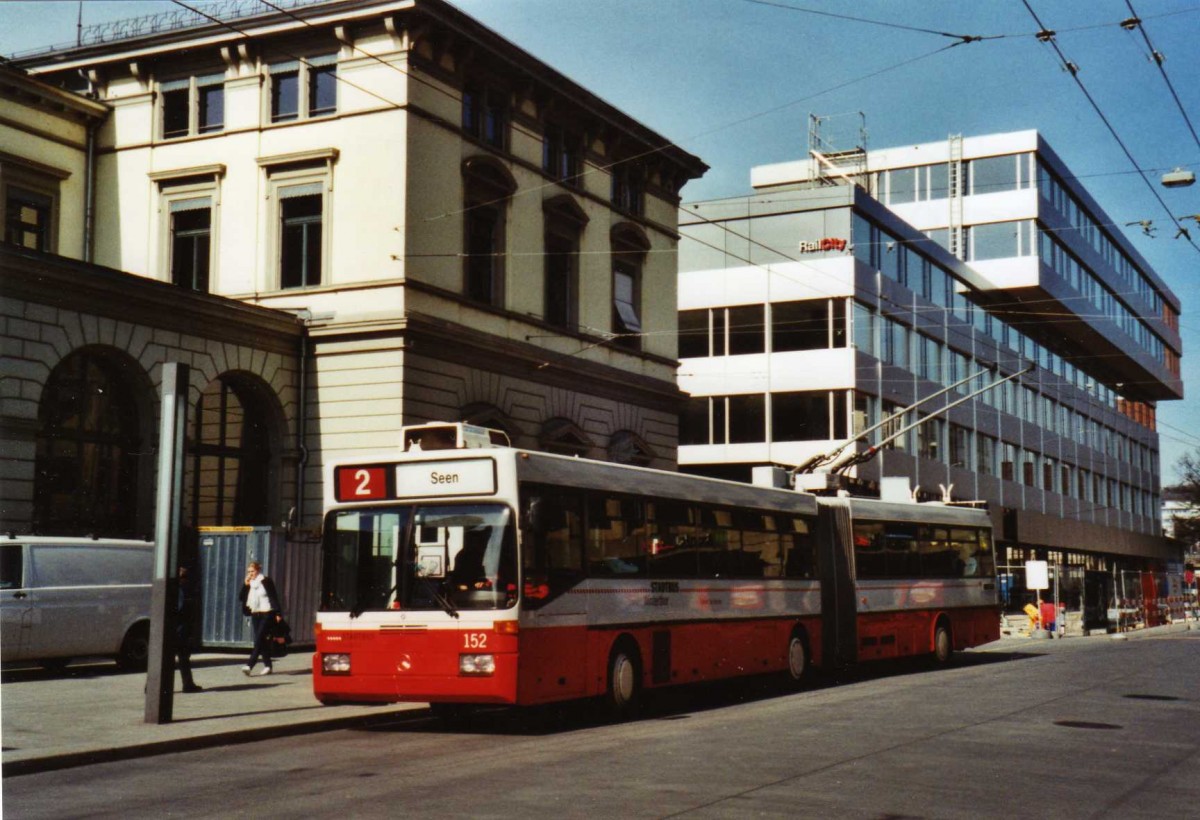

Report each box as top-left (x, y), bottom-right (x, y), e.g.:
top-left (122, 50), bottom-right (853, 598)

top-left (188, 376), bottom-right (271, 527)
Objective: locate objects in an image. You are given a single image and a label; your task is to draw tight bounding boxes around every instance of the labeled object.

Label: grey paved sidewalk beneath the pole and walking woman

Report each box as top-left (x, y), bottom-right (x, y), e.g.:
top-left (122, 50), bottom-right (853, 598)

top-left (0, 652), bottom-right (425, 778)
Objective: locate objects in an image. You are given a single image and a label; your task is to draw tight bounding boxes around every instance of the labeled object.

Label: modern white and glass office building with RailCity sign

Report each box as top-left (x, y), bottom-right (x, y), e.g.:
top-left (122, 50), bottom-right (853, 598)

top-left (679, 132), bottom-right (1182, 612)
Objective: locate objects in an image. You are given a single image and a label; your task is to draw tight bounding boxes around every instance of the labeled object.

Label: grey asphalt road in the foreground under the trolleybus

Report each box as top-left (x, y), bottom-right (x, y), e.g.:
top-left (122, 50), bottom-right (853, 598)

top-left (4, 632), bottom-right (1200, 820)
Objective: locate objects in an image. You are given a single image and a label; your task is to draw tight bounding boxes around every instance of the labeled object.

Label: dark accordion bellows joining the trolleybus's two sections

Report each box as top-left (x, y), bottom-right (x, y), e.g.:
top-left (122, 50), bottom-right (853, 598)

top-left (817, 498), bottom-right (858, 670)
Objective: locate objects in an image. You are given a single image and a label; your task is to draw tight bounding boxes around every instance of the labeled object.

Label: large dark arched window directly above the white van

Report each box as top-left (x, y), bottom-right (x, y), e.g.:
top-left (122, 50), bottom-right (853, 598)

top-left (32, 351), bottom-right (144, 538)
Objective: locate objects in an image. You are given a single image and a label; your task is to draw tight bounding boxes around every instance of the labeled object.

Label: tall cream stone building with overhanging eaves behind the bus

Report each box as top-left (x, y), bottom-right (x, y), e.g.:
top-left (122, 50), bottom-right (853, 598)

top-left (2, 0), bottom-right (706, 535)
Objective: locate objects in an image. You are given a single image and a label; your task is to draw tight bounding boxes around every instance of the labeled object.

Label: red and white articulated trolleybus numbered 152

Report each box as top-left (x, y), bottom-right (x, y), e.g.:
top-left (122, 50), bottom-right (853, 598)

top-left (313, 424), bottom-right (1000, 717)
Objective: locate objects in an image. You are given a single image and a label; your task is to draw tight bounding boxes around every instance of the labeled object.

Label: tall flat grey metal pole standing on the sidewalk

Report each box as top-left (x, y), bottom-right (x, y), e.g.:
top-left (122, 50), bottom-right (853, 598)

top-left (145, 361), bottom-right (190, 724)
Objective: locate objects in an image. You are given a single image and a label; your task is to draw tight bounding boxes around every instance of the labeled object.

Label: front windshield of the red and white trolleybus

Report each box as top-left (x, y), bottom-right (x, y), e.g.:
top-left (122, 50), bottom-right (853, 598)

top-left (322, 504), bottom-right (517, 616)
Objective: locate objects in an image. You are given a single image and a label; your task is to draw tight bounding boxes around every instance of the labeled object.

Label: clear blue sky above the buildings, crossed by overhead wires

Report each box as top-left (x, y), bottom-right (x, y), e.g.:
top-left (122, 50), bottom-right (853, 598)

top-left (7, 0), bottom-right (1200, 483)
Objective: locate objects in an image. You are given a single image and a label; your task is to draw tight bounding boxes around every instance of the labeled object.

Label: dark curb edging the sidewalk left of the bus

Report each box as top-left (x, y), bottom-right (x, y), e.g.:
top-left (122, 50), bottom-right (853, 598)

top-left (2, 704), bottom-right (427, 779)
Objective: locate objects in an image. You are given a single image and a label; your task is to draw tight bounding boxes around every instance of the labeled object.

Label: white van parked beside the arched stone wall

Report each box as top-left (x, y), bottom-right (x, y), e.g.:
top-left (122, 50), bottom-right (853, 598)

top-left (0, 535), bottom-right (154, 669)
